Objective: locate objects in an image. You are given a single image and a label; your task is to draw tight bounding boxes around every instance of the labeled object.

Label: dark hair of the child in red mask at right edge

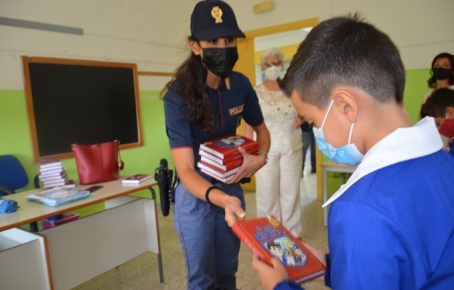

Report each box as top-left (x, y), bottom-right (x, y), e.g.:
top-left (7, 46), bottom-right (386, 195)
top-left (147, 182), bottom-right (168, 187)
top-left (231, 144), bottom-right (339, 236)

top-left (420, 88), bottom-right (454, 118)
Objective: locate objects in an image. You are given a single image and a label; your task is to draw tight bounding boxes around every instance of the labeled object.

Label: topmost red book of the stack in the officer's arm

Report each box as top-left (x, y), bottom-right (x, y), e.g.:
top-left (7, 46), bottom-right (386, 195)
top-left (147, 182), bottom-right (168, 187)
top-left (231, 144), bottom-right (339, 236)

top-left (200, 134), bottom-right (259, 160)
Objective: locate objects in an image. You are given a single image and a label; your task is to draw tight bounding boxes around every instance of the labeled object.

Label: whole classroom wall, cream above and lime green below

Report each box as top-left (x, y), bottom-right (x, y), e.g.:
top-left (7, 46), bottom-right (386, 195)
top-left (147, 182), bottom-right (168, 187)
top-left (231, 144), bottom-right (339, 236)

top-left (0, 0), bottom-right (454, 195)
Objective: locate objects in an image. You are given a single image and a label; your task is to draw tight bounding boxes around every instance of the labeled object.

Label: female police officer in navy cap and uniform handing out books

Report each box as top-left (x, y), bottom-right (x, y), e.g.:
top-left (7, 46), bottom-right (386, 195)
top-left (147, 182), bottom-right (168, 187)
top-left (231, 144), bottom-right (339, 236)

top-left (163, 0), bottom-right (270, 290)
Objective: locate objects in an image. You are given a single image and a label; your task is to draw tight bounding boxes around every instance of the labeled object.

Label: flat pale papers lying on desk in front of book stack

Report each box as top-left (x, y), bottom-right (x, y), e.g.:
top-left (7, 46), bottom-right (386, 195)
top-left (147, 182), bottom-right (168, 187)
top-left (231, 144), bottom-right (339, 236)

top-left (27, 187), bottom-right (93, 206)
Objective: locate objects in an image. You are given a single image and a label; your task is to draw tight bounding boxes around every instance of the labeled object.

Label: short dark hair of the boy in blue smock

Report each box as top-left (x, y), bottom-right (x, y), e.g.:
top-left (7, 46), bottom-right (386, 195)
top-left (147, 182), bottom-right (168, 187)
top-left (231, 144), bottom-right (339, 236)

top-left (280, 14), bottom-right (405, 108)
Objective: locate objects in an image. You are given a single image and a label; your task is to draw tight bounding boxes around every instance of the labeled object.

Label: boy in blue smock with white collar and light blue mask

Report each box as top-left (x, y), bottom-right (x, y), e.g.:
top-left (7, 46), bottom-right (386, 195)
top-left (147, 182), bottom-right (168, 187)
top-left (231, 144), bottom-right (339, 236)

top-left (248, 15), bottom-right (454, 290)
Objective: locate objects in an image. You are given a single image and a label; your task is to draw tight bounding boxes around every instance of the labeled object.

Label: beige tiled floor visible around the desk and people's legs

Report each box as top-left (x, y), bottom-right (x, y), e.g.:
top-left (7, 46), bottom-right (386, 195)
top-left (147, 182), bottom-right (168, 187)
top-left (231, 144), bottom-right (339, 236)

top-left (73, 168), bottom-right (328, 290)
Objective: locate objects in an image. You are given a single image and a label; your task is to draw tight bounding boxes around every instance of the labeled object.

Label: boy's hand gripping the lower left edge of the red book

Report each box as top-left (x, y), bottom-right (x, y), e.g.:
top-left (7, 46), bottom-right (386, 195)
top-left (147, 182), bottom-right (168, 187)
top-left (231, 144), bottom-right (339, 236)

top-left (252, 255), bottom-right (288, 290)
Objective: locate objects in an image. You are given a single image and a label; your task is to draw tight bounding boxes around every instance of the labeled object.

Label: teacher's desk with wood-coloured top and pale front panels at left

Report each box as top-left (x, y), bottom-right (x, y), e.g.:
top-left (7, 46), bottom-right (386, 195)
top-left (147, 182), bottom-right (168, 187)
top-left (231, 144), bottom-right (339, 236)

top-left (0, 179), bottom-right (164, 289)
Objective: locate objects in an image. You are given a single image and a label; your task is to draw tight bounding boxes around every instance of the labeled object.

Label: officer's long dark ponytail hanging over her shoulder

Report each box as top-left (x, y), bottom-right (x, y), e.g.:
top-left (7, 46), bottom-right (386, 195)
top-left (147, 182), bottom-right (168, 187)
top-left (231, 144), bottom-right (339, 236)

top-left (161, 36), bottom-right (218, 134)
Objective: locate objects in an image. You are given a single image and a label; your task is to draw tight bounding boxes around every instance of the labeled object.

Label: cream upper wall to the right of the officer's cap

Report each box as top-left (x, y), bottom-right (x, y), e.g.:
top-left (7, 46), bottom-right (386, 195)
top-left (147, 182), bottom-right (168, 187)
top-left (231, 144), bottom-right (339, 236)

top-left (228, 0), bottom-right (454, 70)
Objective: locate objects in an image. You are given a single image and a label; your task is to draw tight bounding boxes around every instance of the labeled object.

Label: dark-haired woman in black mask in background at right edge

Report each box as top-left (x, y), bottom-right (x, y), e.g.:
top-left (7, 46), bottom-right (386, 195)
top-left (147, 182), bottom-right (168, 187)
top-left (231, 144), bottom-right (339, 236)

top-left (424, 52), bottom-right (454, 101)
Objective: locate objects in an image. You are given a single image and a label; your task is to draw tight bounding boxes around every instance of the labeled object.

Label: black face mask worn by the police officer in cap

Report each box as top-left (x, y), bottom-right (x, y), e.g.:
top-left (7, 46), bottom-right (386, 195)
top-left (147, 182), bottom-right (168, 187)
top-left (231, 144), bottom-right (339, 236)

top-left (203, 47), bottom-right (238, 78)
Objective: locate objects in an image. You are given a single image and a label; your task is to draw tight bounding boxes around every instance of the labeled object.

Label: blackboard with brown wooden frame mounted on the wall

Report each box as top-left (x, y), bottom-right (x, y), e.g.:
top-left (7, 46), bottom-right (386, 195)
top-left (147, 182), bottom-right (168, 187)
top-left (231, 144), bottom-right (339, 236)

top-left (22, 56), bottom-right (143, 163)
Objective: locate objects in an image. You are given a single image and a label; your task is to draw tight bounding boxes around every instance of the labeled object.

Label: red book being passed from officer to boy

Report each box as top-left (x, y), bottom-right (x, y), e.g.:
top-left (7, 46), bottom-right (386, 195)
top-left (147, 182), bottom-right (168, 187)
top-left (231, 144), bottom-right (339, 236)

top-left (232, 215), bottom-right (326, 283)
